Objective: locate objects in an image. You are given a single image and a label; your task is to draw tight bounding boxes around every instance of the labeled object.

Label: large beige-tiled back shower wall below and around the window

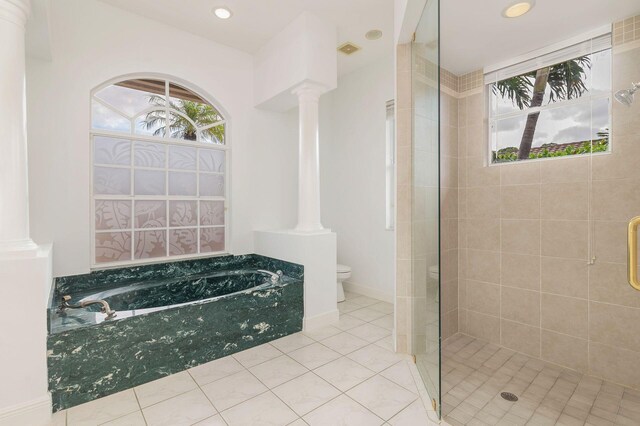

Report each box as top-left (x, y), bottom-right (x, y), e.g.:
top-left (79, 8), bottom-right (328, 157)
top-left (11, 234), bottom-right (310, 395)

top-left (458, 17), bottom-right (640, 388)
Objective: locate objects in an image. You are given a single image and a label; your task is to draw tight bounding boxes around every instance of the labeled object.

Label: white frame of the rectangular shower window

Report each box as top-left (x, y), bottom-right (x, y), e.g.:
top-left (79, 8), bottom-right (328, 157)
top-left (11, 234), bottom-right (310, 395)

top-left (483, 47), bottom-right (614, 167)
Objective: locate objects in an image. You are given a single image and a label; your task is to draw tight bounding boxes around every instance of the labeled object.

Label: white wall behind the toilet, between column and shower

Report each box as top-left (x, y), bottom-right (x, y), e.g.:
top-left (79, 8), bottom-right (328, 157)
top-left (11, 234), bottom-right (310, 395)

top-left (320, 52), bottom-right (395, 300)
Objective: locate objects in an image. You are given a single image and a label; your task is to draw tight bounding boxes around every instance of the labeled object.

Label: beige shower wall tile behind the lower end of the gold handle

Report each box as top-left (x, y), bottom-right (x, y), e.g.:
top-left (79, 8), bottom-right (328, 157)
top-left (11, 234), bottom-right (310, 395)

top-left (589, 262), bottom-right (640, 308)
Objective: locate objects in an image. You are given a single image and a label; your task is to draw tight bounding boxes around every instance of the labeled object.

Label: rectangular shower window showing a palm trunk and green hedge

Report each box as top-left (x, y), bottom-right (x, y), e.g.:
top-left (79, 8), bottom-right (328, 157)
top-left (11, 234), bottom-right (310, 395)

top-left (485, 34), bottom-right (611, 163)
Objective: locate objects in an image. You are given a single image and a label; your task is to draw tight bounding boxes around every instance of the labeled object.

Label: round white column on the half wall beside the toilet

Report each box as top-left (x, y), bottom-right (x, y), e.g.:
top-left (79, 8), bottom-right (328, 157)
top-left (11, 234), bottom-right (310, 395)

top-left (293, 83), bottom-right (329, 234)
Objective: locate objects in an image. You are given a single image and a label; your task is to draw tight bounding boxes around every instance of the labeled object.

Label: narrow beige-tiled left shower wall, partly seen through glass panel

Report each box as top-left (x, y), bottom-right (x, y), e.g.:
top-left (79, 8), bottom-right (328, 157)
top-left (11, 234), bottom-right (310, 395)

top-left (396, 44), bottom-right (459, 358)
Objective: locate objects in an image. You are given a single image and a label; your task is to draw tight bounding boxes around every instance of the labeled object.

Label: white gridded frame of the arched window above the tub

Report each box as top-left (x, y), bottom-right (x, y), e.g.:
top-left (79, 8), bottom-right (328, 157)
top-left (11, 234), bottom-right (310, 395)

top-left (89, 74), bottom-right (231, 270)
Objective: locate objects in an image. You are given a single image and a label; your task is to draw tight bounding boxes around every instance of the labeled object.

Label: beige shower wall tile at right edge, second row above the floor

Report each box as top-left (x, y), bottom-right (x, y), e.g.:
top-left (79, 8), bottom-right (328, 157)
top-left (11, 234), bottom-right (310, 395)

top-left (589, 302), bottom-right (640, 351)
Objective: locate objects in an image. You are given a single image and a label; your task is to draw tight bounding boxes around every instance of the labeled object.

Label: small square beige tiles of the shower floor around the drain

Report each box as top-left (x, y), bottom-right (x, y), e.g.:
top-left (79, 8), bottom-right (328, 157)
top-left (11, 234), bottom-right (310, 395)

top-left (442, 334), bottom-right (640, 426)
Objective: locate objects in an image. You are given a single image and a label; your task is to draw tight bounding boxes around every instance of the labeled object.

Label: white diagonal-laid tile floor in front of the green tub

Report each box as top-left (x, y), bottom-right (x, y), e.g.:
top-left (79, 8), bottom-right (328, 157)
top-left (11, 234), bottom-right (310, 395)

top-left (52, 294), bottom-right (437, 426)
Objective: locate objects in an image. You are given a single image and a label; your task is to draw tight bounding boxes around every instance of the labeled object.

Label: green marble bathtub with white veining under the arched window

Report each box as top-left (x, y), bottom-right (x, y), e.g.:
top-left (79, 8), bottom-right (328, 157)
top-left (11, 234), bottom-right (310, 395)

top-left (47, 255), bottom-right (304, 410)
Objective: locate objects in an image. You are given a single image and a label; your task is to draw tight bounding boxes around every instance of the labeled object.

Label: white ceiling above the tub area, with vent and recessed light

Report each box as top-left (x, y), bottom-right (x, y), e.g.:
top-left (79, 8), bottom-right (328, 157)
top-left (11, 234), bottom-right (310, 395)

top-left (102, 0), bottom-right (393, 75)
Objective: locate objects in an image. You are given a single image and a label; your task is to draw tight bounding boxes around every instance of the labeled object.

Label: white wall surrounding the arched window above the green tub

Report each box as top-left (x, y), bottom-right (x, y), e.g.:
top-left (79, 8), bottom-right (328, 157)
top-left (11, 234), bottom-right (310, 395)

top-left (27, 0), bottom-right (297, 276)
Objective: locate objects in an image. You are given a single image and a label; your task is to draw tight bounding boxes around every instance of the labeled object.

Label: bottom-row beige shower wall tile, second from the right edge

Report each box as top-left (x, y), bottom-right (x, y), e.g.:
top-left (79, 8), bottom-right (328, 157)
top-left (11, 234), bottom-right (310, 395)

top-left (541, 330), bottom-right (589, 373)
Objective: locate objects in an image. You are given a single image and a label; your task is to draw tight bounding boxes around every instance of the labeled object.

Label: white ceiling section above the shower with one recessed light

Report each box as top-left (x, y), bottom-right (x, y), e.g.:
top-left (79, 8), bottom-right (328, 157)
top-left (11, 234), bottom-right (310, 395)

top-left (440, 0), bottom-right (640, 75)
